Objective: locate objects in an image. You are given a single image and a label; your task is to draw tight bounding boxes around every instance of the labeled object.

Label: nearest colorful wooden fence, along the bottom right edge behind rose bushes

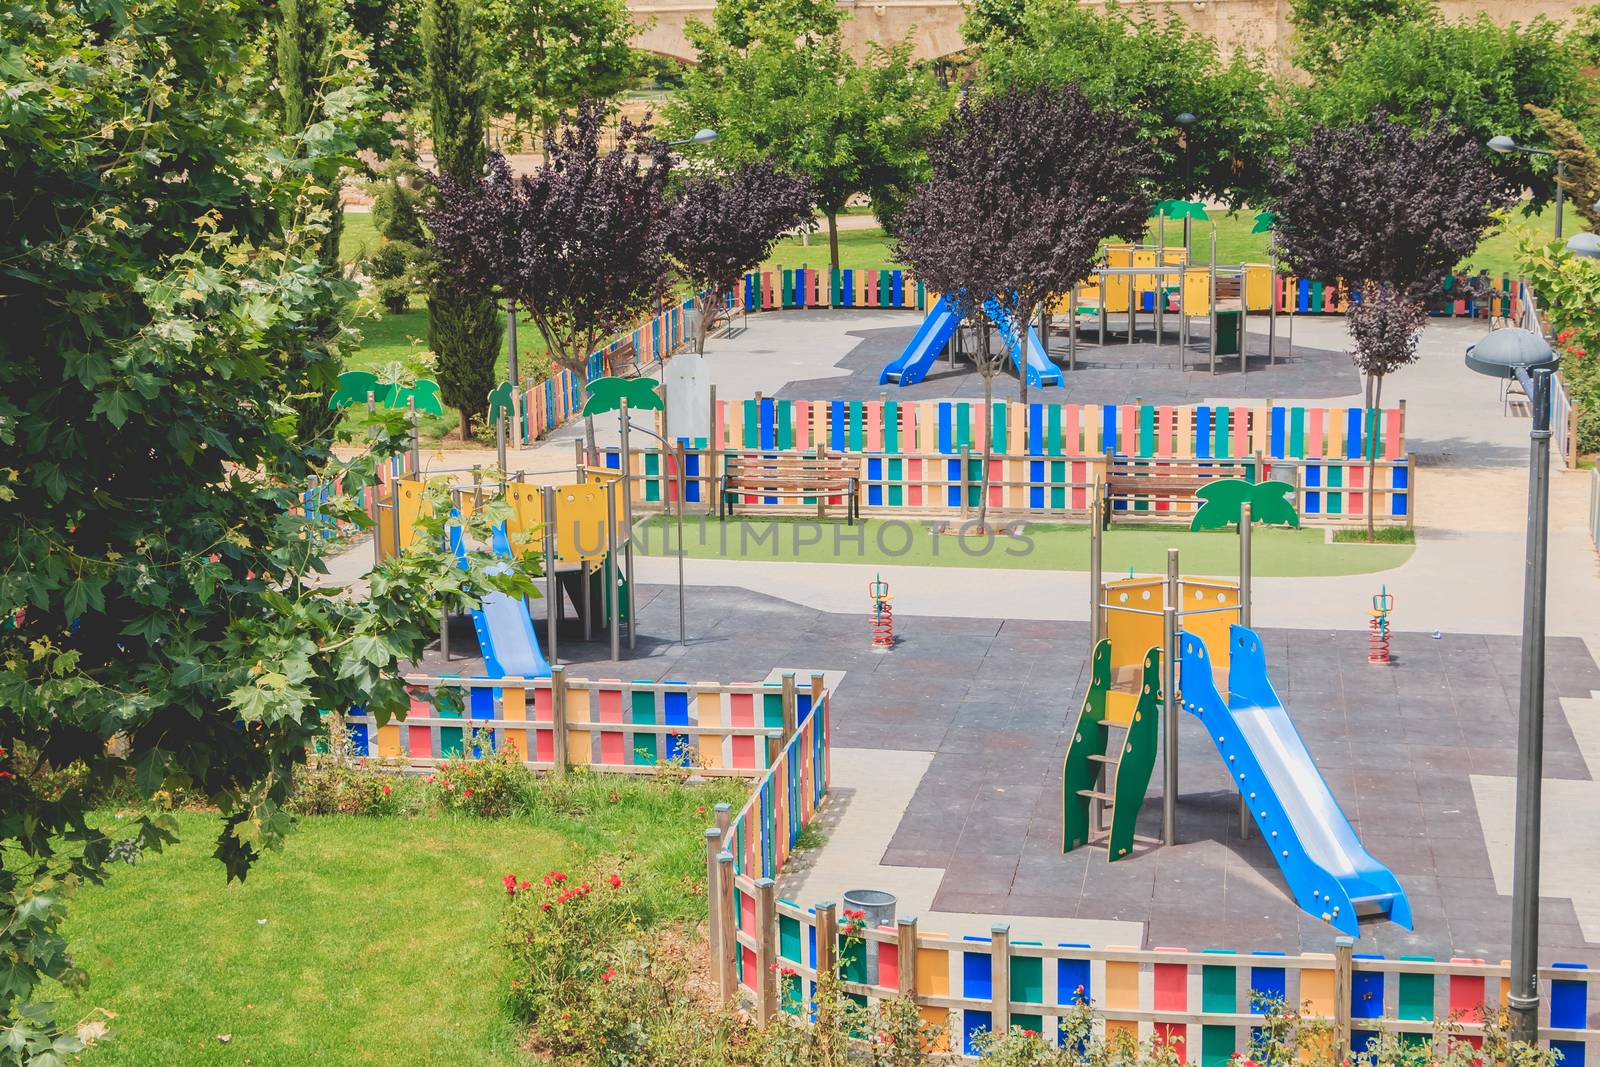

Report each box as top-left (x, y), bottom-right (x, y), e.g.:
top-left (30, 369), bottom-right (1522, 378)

top-left (718, 915), bottom-right (1600, 1067)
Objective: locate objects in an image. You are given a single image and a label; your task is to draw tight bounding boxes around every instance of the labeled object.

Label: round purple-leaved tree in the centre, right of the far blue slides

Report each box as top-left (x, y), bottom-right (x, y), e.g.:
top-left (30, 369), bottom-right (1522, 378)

top-left (894, 86), bottom-right (1155, 533)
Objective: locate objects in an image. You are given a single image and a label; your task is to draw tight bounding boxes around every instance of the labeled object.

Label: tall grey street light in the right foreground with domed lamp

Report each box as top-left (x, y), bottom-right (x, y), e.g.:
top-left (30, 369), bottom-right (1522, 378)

top-left (1467, 326), bottom-right (1576, 1045)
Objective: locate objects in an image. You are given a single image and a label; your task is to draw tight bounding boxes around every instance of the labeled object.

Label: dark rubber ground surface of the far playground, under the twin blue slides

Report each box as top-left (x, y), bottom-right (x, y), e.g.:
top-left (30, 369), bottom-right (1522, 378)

top-left (778, 312), bottom-right (1362, 403)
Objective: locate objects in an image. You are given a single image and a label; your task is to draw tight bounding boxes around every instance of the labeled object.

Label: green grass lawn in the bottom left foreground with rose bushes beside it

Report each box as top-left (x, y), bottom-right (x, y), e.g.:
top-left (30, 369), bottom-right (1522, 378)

top-left (62, 776), bottom-right (744, 1067)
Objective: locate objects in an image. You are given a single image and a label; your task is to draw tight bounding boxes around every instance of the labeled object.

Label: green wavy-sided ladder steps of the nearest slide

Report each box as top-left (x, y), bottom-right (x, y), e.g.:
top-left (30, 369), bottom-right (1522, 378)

top-left (1061, 640), bottom-right (1162, 861)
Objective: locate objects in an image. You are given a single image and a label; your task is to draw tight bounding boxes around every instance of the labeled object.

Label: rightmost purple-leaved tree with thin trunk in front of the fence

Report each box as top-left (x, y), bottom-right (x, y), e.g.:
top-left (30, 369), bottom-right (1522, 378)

top-left (1267, 112), bottom-right (1506, 539)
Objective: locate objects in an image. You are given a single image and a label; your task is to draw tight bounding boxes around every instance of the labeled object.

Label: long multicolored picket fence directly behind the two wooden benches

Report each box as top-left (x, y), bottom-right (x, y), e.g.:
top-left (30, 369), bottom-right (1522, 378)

top-left (606, 397), bottom-right (1414, 525)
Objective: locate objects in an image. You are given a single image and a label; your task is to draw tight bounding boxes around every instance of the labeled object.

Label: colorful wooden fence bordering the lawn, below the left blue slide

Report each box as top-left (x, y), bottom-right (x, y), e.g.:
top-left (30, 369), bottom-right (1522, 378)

top-left (346, 667), bottom-right (829, 777)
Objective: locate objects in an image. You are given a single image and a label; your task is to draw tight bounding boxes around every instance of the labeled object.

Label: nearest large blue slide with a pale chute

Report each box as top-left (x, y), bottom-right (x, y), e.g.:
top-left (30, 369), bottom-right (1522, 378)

top-left (1179, 625), bottom-right (1411, 937)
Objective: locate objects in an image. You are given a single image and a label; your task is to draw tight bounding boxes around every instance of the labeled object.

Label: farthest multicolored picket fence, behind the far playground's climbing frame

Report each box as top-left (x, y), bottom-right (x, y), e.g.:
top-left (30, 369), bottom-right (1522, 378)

top-left (730, 267), bottom-right (1520, 320)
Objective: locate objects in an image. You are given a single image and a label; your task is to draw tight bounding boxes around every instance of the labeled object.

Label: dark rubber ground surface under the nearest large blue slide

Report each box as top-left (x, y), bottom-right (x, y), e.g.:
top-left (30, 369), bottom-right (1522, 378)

top-left (427, 585), bottom-right (1600, 965)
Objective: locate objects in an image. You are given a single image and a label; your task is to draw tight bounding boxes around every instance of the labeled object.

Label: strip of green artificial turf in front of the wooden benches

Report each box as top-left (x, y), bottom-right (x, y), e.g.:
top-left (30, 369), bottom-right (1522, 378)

top-left (638, 515), bottom-right (1413, 577)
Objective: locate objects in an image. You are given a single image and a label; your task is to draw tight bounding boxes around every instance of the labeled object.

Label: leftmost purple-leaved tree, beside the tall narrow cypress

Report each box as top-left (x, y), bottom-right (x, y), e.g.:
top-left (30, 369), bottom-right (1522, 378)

top-left (427, 101), bottom-right (670, 459)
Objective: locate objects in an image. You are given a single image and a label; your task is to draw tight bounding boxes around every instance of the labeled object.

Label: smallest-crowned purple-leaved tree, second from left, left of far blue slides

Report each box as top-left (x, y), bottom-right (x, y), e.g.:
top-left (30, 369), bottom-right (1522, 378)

top-left (667, 162), bottom-right (814, 352)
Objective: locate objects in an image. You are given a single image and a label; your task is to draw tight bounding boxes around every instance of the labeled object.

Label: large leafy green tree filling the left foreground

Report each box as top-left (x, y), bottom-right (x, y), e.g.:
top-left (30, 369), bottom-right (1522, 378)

top-left (0, 0), bottom-right (531, 1067)
